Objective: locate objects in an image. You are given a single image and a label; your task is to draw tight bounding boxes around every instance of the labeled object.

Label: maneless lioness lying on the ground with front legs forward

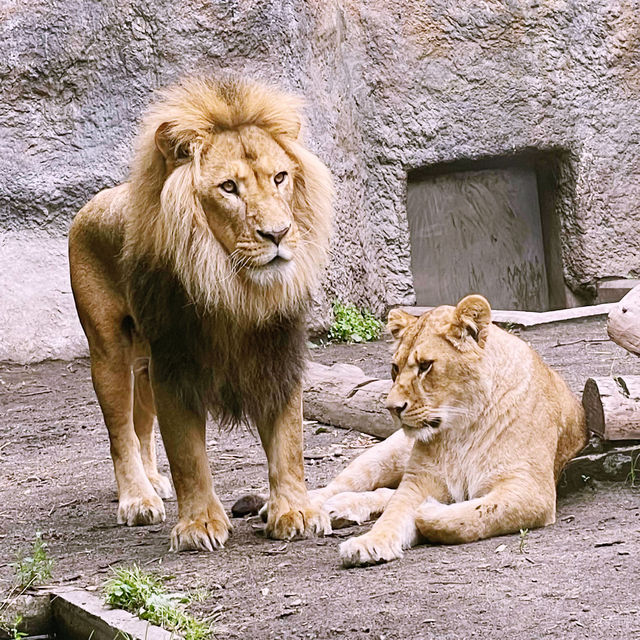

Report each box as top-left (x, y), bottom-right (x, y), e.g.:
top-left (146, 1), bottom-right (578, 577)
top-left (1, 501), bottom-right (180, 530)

top-left (311, 295), bottom-right (587, 566)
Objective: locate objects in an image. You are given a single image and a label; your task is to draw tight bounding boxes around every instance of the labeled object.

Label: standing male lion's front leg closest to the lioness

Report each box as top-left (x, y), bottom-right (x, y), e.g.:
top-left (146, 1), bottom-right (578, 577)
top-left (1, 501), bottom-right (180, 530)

top-left (258, 389), bottom-right (331, 540)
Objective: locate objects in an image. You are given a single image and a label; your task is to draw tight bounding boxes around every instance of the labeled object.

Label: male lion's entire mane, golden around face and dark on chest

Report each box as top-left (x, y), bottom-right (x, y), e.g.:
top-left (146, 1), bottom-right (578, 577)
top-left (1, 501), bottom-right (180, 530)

top-left (123, 79), bottom-right (333, 425)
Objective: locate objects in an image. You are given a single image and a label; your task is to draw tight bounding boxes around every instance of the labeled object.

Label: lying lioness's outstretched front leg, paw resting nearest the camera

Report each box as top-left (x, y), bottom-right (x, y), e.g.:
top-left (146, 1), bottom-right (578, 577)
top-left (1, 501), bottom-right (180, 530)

top-left (340, 442), bottom-right (448, 567)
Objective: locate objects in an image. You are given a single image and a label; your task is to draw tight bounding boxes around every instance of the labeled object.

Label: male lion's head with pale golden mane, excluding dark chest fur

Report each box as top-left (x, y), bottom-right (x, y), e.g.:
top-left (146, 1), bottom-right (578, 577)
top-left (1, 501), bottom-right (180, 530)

top-left (123, 78), bottom-right (333, 327)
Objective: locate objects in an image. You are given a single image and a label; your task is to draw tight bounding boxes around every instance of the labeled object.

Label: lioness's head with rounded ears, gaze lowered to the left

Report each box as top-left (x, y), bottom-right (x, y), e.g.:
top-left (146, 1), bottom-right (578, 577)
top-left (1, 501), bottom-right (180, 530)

top-left (387, 296), bottom-right (491, 441)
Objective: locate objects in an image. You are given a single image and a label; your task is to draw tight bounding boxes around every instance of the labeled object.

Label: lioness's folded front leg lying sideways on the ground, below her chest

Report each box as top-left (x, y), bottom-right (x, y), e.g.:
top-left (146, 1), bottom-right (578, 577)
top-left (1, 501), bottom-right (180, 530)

top-left (416, 474), bottom-right (556, 544)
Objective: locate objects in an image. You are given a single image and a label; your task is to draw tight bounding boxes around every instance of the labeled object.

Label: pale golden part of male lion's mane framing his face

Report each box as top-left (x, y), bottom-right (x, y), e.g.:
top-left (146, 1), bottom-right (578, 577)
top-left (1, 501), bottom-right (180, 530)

top-left (124, 78), bottom-right (333, 326)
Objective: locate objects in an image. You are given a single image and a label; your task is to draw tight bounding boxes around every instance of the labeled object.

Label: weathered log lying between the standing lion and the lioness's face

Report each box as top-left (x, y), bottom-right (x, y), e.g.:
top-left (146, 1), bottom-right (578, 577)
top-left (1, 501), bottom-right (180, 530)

top-left (304, 362), bottom-right (396, 438)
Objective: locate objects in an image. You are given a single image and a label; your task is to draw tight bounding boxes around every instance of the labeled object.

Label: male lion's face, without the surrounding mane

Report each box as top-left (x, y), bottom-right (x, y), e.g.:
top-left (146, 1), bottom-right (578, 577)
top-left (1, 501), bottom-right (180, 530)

top-left (195, 126), bottom-right (300, 284)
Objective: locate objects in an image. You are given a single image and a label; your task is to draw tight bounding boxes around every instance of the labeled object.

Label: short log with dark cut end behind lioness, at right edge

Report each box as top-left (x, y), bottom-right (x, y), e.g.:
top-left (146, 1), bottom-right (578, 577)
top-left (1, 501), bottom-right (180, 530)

top-left (582, 376), bottom-right (640, 440)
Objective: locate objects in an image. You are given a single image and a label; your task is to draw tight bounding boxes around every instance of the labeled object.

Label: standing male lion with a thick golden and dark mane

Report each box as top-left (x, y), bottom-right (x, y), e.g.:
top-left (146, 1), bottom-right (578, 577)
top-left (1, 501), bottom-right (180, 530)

top-left (69, 78), bottom-right (333, 551)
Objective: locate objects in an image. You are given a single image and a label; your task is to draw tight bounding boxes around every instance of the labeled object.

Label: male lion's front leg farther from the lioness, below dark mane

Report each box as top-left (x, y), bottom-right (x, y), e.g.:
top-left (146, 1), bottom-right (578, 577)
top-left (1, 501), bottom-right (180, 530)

top-left (152, 378), bottom-right (231, 551)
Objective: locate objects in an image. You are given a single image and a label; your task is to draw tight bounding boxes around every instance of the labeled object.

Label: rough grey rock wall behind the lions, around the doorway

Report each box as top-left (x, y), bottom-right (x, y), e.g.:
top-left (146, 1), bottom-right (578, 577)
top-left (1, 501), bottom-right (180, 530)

top-left (0, 0), bottom-right (640, 359)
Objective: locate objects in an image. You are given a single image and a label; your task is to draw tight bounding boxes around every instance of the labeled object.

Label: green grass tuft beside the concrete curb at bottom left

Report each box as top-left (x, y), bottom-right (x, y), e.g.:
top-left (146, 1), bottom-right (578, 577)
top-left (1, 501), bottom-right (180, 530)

top-left (104, 565), bottom-right (214, 640)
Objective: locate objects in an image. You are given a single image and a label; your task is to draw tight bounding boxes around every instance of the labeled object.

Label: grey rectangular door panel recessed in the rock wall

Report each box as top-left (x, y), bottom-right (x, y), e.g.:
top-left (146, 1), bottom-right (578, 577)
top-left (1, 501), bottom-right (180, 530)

top-left (407, 159), bottom-right (565, 311)
